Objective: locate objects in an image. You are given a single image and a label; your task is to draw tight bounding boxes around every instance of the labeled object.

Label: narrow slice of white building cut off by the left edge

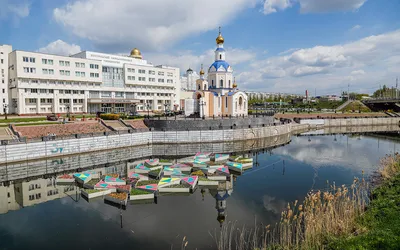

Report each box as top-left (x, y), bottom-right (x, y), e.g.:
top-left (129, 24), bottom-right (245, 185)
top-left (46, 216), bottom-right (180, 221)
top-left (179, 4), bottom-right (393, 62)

top-left (0, 44), bottom-right (12, 114)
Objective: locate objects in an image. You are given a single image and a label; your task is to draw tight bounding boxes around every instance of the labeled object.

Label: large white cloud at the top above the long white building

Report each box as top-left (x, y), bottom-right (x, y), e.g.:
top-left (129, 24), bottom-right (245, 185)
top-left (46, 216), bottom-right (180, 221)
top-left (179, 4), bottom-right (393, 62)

top-left (53, 0), bottom-right (258, 50)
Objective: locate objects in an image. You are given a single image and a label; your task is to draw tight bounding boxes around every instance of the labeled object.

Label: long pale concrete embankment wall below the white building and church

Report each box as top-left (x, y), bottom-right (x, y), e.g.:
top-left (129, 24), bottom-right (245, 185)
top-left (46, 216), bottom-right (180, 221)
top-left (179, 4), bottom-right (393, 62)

top-left (0, 124), bottom-right (308, 164)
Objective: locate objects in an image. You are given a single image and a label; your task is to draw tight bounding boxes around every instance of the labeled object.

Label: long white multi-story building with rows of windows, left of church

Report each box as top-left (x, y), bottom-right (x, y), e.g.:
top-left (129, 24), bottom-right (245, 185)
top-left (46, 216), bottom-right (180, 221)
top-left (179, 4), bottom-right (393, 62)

top-left (8, 49), bottom-right (180, 114)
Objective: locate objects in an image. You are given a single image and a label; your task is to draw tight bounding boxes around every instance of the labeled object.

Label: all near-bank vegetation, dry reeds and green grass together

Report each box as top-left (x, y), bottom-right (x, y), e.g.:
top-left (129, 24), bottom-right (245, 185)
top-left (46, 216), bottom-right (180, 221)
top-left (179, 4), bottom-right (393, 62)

top-left (205, 153), bottom-right (400, 250)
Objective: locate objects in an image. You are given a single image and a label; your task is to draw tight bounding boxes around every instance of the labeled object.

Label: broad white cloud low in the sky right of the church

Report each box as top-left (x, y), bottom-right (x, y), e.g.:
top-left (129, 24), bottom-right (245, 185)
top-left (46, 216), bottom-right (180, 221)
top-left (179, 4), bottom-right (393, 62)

top-left (238, 30), bottom-right (400, 93)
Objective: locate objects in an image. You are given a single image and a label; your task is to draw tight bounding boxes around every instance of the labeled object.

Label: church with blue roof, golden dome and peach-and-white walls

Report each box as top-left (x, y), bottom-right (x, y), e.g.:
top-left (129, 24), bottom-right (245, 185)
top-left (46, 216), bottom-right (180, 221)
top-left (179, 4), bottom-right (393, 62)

top-left (185, 27), bottom-right (248, 117)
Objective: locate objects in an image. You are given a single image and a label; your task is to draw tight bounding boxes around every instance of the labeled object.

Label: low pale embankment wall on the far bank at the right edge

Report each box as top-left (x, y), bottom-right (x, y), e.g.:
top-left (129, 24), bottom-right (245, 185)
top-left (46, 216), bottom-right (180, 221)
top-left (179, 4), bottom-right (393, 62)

top-left (300, 117), bottom-right (400, 127)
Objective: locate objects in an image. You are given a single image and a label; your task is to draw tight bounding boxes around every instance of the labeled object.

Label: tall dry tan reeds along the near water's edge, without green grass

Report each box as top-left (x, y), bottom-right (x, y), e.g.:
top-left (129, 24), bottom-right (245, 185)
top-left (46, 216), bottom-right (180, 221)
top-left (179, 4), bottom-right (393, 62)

top-left (212, 153), bottom-right (400, 250)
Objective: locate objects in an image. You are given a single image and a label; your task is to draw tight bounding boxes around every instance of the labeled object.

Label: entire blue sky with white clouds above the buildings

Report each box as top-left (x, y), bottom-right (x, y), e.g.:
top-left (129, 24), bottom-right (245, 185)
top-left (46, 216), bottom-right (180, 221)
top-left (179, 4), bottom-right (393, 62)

top-left (0, 0), bottom-right (400, 95)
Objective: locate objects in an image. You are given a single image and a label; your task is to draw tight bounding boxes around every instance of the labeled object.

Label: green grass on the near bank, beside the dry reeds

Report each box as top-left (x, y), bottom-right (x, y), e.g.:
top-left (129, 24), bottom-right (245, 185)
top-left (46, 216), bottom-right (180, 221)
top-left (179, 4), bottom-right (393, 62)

top-left (326, 175), bottom-right (400, 249)
